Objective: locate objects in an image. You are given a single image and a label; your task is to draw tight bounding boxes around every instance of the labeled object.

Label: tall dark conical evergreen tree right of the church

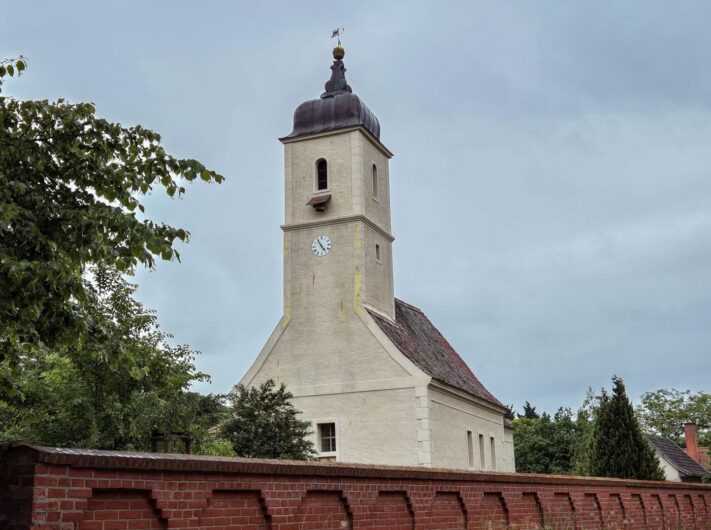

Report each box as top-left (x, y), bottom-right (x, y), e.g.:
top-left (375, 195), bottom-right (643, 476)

top-left (588, 376), bottom-right (664, 480)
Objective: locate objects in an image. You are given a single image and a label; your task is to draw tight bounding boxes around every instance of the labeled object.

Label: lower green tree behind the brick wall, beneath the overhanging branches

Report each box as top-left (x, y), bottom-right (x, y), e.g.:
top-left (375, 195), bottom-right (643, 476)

top-left (0, 267), bottom-right (217, 449)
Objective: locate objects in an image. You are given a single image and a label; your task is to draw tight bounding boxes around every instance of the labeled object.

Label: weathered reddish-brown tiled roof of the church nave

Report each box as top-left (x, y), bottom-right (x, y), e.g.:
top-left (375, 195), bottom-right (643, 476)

top-left (368, 298), bottom-right (504, 408)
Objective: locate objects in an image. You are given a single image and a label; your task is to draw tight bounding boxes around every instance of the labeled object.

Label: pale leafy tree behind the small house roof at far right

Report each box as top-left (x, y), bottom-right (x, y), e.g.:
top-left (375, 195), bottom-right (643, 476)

top-left (637, 388), bottom-right (711, 447)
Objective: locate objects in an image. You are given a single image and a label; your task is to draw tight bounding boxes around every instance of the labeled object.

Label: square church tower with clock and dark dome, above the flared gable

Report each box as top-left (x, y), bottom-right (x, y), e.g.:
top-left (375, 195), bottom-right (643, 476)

top-left (281, 42), bottom-right (395, 322)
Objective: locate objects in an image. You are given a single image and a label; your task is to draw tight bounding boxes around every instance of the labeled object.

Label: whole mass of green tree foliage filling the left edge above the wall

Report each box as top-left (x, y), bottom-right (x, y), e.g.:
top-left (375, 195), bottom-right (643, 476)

top-left (0, 57), bottom-right (231, 454)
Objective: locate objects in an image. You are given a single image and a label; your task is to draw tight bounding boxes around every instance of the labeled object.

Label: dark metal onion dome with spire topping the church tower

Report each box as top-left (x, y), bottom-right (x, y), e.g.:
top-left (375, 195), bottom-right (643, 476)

top-left (286, 46), bottom-right (380, 140)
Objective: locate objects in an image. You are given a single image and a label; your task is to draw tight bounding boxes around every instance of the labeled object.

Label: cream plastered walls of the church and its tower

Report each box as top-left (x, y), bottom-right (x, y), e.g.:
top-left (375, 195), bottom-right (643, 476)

top-left (241, 129), bottom-right (506, 468)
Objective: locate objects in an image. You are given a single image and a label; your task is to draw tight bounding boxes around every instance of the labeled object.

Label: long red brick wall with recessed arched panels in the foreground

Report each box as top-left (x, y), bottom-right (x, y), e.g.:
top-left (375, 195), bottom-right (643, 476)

top-left (0, 446), bottom-right (711, 530)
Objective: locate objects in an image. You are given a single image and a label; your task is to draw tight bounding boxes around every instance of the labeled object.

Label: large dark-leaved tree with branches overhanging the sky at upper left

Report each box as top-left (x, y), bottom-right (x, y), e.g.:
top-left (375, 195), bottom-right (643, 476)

top-left (0, 58), bottom-right (223, 386)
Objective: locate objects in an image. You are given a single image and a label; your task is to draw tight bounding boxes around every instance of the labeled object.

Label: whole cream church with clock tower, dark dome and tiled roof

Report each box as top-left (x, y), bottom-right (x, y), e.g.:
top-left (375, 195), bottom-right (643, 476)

top-left (241, 45), bottom-right (515, 471)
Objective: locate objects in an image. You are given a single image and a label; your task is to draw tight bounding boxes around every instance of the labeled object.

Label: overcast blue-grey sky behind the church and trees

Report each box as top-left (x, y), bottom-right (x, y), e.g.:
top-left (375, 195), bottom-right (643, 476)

top-left (6, 0), bottom-right (711, 410)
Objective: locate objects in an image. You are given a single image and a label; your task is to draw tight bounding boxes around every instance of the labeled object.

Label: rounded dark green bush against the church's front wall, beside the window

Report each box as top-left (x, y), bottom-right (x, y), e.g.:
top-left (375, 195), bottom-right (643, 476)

top-left (221, 379), bottom-right (314, 460)
